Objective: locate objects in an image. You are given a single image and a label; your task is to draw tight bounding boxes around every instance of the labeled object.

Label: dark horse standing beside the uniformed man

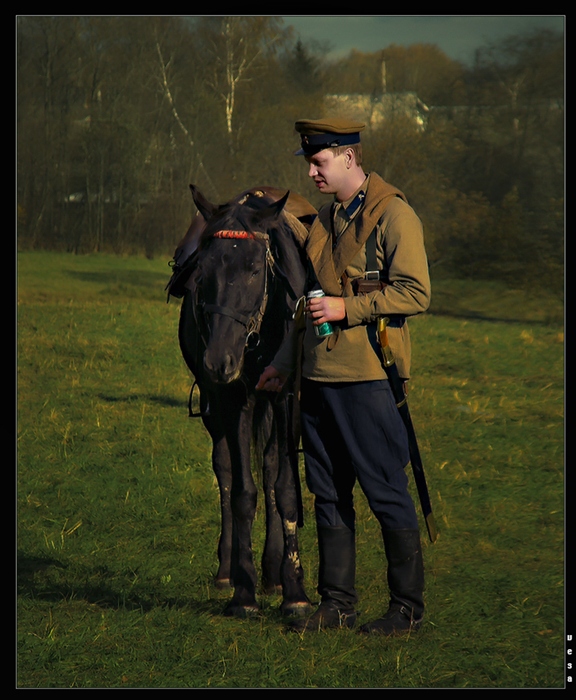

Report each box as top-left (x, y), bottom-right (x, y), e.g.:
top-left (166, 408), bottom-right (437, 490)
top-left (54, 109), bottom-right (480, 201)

top-left (171, 185), bottom-right (313, 617)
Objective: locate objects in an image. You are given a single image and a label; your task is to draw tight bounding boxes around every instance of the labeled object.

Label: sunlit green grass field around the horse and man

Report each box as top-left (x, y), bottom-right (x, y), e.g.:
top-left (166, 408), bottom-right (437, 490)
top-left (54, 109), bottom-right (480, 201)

top-left (15, 253), bottom-right (566, 689)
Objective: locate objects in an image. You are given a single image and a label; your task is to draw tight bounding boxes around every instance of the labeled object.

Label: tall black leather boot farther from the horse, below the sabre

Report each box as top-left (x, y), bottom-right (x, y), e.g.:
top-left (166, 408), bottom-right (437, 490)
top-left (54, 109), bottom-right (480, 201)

top-left (359, 530), bottom-right (424, 636)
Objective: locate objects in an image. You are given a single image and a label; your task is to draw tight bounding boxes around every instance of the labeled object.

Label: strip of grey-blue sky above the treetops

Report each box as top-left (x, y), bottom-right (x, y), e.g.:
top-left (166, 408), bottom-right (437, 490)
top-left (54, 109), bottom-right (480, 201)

top-left (284, 15), bottom-right (565, 63)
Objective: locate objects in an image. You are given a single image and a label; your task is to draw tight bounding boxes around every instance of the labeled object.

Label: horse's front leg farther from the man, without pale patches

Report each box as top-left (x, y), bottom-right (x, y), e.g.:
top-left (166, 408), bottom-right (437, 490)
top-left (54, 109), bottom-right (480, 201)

top-left (224, 405), bottom-right (259, 617)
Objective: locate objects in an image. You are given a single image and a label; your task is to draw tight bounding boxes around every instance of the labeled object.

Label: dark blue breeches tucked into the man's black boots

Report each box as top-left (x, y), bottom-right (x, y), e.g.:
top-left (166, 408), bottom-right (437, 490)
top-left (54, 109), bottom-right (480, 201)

top-left (301, 379), bottom-right (418, 530)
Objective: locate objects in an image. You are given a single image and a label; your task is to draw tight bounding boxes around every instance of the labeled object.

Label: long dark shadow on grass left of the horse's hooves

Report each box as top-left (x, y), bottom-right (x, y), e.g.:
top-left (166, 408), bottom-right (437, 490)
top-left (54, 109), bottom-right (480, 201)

top-left (17, 552), bottom-right (223, 615)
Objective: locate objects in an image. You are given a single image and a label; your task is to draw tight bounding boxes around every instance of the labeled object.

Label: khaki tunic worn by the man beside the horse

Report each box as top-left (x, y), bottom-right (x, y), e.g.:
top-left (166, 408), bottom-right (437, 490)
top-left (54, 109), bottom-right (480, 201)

top-left (272, 173), bottom-right (430, 382)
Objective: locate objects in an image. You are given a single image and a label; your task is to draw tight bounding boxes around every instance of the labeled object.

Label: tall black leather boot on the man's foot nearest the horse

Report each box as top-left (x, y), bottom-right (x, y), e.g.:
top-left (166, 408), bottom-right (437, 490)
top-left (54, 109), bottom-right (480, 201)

top-left (290, 526), bottom-right (357, 632)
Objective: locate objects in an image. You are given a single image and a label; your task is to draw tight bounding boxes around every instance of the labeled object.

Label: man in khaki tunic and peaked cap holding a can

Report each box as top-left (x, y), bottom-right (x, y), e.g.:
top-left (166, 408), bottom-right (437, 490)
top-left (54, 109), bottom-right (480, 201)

top-left (258, 119), bottom-right (430, 635)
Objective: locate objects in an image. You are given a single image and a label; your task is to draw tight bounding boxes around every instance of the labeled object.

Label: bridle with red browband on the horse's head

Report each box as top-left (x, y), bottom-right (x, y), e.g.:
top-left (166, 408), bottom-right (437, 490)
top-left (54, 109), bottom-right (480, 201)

top-left (196, 229), bottom-right (274, 350)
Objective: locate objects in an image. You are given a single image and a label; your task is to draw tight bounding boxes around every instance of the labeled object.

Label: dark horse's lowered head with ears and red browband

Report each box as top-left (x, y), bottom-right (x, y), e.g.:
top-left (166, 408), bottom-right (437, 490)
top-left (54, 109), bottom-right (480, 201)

top-left (191, 186), bottom-right (304, 383)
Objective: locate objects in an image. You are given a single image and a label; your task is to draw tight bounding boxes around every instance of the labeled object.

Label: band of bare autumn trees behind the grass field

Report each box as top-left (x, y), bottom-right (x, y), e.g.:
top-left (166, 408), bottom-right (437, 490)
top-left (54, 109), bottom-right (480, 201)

top-left (17, 16), bottom-right (564, 294)
